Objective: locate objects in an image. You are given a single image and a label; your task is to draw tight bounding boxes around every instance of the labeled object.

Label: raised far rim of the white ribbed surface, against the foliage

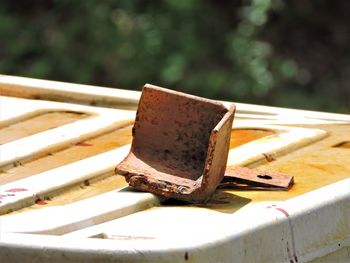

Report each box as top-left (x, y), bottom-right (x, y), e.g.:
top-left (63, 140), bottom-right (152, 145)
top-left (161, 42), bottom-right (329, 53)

top-left (0, 74), bottom-right (350, 122)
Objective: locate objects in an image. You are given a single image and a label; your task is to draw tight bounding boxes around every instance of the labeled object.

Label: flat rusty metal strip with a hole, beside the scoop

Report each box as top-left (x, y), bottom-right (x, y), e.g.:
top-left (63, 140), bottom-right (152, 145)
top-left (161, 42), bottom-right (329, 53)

top-left (220, 167), bottom-right (294, 190)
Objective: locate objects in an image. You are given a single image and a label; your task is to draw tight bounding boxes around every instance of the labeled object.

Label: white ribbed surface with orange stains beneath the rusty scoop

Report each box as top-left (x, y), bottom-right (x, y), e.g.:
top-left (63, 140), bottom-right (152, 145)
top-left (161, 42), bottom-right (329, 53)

top-left (0, 75), bottom-right (350, 262)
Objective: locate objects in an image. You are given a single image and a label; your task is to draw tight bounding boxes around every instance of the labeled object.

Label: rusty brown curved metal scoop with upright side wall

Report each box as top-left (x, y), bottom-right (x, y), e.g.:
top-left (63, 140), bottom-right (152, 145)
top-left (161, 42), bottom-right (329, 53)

top-left (116, 84), bottom-right (235, 202)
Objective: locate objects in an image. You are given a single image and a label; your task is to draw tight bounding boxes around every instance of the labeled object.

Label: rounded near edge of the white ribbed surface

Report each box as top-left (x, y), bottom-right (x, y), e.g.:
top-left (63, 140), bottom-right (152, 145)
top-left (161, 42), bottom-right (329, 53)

top-left (0, 179), bottom-right (350, 262)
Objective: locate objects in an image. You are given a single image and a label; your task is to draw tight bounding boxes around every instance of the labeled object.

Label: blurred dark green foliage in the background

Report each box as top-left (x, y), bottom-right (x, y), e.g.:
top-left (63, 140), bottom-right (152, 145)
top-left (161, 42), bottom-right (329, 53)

top-left (0, 0), bottom-right (350, 112)
